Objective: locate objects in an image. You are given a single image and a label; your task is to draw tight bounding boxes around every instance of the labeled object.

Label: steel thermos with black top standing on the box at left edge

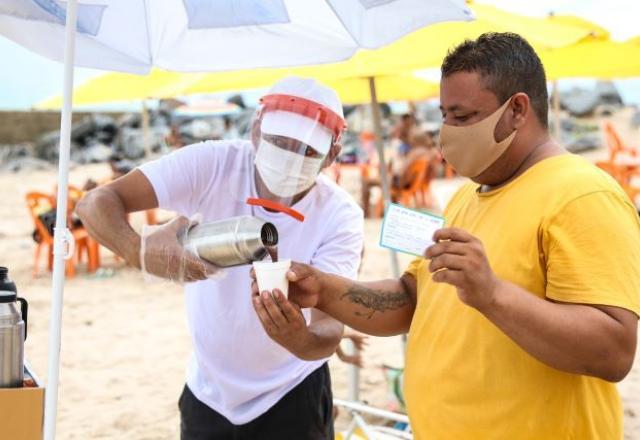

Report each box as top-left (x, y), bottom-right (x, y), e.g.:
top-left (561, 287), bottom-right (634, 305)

top-left (0, 267), bottom-right (28, 388)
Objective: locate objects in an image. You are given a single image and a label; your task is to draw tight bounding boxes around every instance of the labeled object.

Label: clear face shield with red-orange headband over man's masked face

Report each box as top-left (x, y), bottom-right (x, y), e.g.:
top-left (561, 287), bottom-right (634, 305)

top-left (251, 95), bottom-right (345, 207)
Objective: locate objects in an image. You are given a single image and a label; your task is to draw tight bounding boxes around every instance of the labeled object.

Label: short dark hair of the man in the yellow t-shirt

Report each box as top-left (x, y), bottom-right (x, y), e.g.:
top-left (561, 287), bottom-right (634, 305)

top-left (441, 32), bottom-right (549, 128)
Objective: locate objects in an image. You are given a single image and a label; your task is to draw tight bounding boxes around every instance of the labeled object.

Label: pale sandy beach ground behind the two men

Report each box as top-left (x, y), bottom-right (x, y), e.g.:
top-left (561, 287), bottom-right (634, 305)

top-left (0, 115), bottom-right (640, 440)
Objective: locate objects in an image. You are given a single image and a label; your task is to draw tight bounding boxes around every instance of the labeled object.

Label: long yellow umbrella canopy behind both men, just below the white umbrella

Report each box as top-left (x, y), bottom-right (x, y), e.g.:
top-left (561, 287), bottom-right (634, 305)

top-left (36, 4), bottom-right (596, 108)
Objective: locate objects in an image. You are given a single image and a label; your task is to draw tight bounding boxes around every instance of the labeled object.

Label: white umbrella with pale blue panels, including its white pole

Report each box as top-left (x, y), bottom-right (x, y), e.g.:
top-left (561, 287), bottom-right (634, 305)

top-left (0, 0), bottom-right (473, 440)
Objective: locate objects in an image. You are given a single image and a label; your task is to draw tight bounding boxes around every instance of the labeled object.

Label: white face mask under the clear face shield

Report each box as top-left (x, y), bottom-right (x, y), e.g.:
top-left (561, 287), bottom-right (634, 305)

top-left (255, 139), bottom-right (324, 197)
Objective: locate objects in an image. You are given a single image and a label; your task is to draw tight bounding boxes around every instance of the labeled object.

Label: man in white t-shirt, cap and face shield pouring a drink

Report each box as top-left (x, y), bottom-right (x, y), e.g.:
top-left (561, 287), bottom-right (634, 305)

top-left (77, 78), bottom-right (363, 439)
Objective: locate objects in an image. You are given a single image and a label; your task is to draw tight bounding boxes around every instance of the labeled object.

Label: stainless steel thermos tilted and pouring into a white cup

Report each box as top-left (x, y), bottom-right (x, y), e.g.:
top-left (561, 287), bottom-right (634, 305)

top-left (182, 215), bottom-right (278, 267)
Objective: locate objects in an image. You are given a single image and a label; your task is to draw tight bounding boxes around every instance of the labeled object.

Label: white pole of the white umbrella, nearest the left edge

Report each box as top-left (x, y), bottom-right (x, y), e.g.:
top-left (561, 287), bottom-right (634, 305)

top-left (44, 0), bottom-right (78, 440)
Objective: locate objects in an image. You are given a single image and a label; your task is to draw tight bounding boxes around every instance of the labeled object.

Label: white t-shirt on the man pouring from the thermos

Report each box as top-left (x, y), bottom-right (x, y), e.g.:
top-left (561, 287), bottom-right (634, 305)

top-left (140, 140), bottom-right (363, 424)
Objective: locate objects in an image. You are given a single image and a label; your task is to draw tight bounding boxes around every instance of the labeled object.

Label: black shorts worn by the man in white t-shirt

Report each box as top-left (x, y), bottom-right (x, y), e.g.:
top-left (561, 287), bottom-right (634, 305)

top-left (178, 364), bottom-right (334, 440)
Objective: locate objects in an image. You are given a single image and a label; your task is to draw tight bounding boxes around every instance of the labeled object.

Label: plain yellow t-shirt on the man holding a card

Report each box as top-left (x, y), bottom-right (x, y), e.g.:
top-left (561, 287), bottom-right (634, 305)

top-left (404, 155), bottom-right (640, 440)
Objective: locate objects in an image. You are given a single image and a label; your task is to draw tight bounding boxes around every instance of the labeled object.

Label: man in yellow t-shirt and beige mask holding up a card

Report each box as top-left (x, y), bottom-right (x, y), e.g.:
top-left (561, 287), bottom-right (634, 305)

top-left (254, 34), bottom-right (640, 440)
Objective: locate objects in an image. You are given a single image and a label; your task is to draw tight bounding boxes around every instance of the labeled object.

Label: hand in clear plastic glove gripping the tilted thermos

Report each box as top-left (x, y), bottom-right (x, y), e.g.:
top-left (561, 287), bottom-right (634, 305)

top-left (140, 216), bottom-right (221, 283)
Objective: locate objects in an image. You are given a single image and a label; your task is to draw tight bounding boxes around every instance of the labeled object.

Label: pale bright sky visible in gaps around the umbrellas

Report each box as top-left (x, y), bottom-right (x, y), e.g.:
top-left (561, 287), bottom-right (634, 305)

top-left (0, 0), bottom-right (640, 110)
